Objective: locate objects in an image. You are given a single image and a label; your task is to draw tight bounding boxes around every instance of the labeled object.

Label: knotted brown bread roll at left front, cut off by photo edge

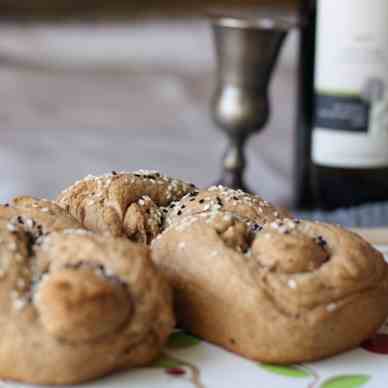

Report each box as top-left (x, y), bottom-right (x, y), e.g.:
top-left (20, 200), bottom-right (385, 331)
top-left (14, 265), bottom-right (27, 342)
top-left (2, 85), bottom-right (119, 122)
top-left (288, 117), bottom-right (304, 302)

top-left (0, 197), bottom-right (175, 384)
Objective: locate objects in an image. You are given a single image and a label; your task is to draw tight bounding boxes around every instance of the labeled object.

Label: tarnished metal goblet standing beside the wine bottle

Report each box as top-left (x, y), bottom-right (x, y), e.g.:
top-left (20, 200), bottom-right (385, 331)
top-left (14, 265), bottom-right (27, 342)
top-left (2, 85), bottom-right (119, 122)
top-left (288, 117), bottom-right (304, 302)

top-left (211, 11), bottom-right (296, 191)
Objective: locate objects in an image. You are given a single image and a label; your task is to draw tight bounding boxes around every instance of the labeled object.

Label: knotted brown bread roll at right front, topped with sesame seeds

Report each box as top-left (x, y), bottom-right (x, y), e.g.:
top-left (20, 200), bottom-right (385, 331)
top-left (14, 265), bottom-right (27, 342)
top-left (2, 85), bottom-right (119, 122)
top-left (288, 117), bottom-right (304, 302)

top-left (152, 203), bottom-right (388, 364)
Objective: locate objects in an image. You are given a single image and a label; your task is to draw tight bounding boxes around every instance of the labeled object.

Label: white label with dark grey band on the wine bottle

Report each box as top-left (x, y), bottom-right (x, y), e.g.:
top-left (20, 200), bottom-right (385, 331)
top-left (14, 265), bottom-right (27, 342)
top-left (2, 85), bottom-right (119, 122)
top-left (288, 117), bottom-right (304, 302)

top-left (312, 0), bottom-right (388, 168)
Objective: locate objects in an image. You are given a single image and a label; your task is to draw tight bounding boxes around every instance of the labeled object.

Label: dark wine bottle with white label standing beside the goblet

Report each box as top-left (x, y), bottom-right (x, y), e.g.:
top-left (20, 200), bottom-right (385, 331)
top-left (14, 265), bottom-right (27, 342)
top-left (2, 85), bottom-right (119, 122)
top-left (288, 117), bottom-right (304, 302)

top-left (297, 0), bottom-right (388, 209)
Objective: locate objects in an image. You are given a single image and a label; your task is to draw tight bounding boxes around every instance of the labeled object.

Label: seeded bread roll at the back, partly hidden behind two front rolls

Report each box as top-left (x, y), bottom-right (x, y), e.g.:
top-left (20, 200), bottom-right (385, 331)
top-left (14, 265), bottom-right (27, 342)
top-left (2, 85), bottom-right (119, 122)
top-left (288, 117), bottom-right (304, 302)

top-left (57, 170), bottom-right (195, 243)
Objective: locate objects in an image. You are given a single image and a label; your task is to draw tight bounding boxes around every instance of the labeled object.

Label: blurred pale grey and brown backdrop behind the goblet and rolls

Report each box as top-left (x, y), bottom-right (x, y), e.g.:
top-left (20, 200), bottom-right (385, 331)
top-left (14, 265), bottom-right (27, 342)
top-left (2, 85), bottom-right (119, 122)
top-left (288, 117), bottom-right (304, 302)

top-left (0, 0), bottom-right (298, 206)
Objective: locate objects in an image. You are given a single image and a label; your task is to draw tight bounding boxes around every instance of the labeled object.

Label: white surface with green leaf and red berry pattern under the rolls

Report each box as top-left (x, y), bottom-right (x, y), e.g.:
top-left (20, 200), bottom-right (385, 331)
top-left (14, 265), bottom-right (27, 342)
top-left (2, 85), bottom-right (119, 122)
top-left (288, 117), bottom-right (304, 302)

top-left (0, 246), bottom-right (388, 388)
